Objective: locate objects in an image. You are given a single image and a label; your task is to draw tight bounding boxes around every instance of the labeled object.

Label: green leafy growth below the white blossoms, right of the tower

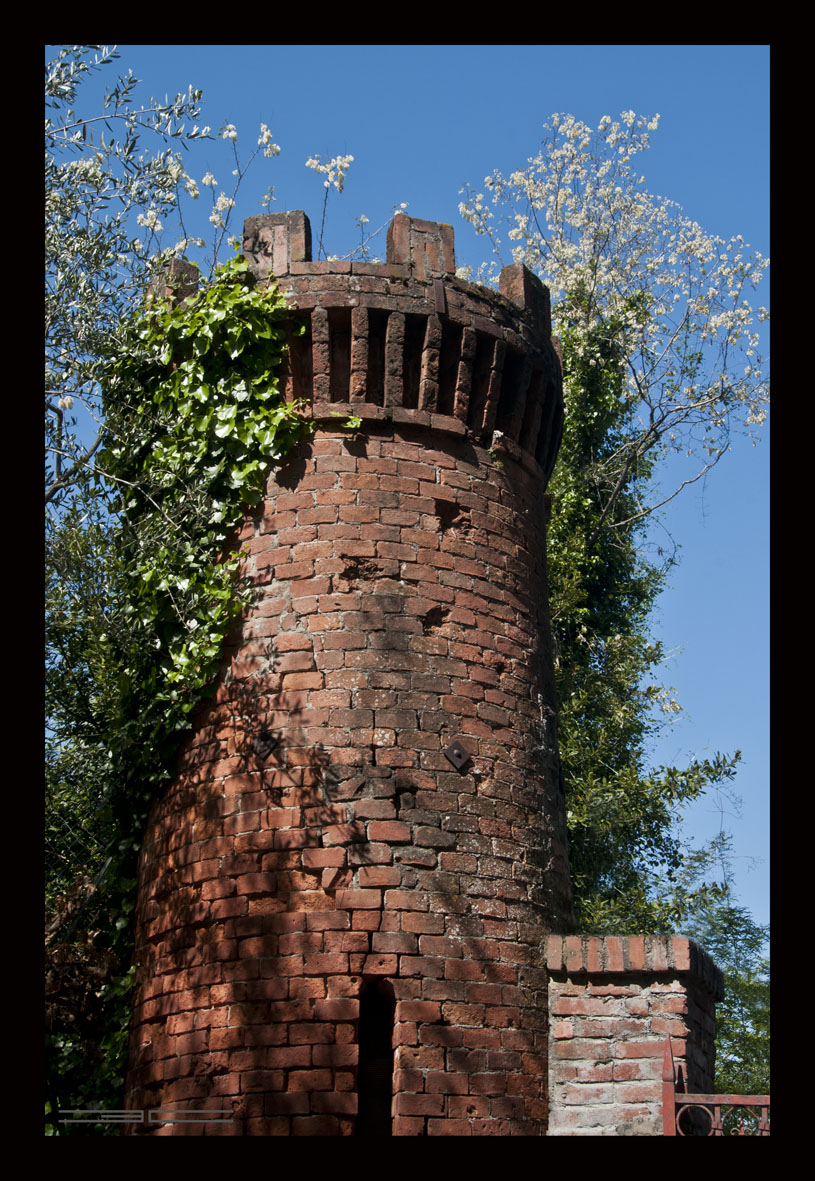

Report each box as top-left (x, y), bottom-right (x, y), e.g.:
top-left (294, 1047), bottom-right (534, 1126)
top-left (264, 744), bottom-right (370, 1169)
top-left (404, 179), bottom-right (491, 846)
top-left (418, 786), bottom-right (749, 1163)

top-left (548, 299), bottom-right (739, 933)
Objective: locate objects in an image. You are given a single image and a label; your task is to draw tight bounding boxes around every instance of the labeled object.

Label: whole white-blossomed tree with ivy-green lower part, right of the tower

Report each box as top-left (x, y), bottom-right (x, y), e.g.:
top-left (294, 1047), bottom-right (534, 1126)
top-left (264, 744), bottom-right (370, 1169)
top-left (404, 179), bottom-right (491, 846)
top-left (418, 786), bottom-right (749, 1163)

top-left (461, 111), bottom-right (769, 932)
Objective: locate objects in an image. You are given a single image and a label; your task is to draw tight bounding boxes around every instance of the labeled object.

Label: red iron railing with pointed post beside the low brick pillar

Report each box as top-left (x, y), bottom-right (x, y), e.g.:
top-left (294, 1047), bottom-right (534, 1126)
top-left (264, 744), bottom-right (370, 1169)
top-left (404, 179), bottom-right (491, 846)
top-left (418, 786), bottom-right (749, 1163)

top-left (663, 1037), bottom-right (770, 1136)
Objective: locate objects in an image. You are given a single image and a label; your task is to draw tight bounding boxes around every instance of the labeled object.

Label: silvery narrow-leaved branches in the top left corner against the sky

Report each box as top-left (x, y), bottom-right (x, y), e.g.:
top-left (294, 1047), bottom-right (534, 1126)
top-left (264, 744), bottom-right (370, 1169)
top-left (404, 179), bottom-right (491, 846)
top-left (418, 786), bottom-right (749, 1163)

top-left (45, 45), bottom-right (209, 507)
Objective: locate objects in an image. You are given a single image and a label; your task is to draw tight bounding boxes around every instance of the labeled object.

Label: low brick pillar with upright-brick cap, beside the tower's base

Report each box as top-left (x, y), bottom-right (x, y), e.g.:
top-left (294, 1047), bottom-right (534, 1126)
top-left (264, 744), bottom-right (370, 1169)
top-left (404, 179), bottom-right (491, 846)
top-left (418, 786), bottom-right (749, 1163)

top-left (546, 935), bottom-right (724, 1136)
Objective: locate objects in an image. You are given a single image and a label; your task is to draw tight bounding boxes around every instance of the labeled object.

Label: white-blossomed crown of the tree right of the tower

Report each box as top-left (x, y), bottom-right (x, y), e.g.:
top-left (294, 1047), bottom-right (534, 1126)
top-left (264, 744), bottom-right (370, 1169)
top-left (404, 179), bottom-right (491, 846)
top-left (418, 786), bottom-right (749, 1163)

top-left (459, 111), bottom-right (769, 484)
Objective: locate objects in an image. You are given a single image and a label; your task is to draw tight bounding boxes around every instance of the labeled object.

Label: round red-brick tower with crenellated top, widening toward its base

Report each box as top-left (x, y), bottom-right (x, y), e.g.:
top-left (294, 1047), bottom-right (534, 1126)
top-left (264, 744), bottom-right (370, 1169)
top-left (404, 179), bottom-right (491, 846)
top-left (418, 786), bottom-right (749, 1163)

top-left (128, 213), bottom-right (573, 1135)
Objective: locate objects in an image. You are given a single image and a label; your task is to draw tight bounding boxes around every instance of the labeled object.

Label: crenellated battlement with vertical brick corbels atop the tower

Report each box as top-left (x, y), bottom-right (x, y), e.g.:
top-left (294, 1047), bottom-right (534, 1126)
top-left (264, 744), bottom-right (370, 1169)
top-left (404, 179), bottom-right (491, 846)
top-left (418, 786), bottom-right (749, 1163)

top-left (243, 210), bottom-right (563, 479)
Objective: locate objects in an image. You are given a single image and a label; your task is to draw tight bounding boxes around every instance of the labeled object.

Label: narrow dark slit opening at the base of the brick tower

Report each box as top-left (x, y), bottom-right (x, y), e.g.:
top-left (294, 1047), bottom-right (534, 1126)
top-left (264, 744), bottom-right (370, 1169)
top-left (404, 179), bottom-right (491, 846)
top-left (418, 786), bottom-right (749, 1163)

top-left (354, 980), bottom-right (396, 1136)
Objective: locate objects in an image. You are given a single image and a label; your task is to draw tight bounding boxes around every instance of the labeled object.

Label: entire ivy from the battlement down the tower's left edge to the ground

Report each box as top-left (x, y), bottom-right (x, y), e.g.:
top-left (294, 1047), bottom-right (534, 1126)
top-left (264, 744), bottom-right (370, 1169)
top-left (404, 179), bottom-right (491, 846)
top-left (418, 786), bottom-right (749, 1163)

top-left (45, 257), bottom-right (311, 1131)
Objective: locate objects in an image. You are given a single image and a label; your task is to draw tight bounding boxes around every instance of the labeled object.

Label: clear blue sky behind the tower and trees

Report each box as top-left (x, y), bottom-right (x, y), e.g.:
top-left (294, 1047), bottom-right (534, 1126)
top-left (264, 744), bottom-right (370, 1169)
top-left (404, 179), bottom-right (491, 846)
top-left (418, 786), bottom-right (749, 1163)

top-left (69, 45), bottom-right (770, 922)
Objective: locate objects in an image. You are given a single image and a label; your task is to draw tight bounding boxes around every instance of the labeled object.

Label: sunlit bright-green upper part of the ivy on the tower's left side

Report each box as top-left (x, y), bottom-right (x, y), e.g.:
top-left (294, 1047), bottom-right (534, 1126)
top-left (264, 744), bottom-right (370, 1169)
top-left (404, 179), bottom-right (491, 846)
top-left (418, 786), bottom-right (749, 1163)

top-left (104, 257), bottom-right (311, 820)
